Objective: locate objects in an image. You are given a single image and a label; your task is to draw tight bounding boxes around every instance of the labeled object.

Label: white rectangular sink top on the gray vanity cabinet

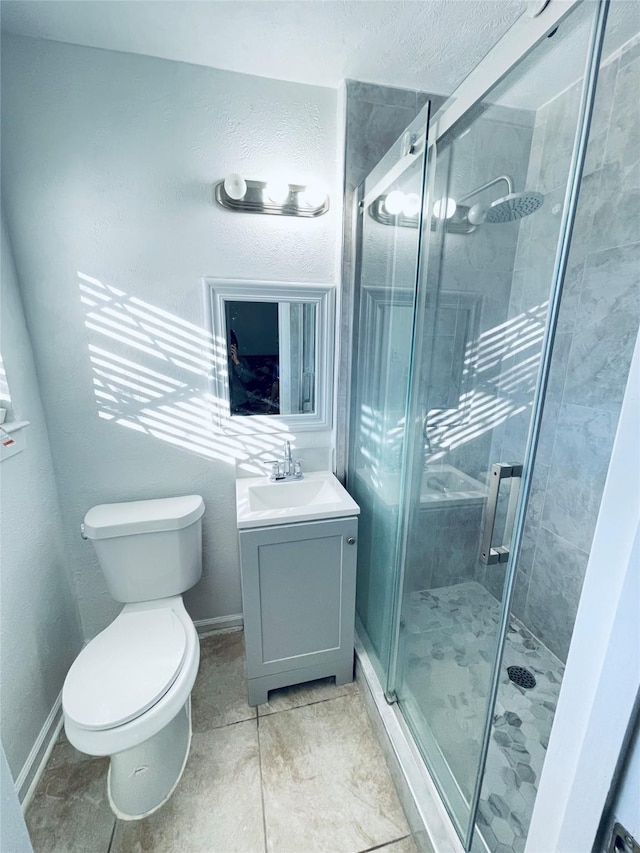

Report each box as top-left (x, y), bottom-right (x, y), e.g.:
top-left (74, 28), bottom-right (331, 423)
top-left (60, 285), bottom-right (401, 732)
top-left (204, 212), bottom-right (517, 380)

top-left (236, 471), bottom-right (360, 529)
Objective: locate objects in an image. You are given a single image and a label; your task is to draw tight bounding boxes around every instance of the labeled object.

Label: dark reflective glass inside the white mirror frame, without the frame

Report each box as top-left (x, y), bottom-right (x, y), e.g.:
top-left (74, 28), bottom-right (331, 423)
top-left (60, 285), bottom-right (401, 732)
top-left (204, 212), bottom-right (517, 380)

top-left (224, 300), bottom-right (316, 415)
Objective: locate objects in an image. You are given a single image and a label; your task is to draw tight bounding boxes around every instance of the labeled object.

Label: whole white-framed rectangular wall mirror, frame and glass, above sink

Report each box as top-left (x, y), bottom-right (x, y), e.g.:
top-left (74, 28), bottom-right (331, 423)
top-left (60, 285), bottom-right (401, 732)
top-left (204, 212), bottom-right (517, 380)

top-left (205, 278), bottom-right (334, 432)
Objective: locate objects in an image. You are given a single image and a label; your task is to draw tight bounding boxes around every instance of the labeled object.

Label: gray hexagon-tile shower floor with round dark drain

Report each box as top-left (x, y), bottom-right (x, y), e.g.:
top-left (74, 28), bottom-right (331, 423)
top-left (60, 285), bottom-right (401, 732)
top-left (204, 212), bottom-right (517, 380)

top-left (405, 581), bottom-right (564, 853)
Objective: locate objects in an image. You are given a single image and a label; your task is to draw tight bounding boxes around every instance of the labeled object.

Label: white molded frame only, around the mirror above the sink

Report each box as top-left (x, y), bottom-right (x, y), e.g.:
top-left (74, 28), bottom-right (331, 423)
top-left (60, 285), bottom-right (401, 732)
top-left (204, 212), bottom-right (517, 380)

top-left (204, 278), bottom-right (335, 434)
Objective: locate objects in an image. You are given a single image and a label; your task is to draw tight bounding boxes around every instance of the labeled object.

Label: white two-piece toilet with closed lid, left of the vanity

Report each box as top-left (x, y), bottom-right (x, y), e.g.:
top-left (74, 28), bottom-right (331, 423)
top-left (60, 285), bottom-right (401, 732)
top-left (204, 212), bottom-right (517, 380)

top-left (62, 495), bottom-right (204, 820)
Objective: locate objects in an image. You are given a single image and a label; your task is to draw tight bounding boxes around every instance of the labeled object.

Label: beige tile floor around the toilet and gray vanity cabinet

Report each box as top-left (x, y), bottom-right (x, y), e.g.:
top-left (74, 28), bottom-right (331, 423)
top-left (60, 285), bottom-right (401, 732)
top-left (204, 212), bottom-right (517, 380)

top-left (27, 631), bottom-right (417, 853)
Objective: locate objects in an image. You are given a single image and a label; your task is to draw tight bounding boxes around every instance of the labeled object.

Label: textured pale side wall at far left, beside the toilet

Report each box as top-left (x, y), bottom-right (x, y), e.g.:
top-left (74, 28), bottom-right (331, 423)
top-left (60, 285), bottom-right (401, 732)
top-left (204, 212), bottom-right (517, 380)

top-left (0, 213), bottom-right (82, 780)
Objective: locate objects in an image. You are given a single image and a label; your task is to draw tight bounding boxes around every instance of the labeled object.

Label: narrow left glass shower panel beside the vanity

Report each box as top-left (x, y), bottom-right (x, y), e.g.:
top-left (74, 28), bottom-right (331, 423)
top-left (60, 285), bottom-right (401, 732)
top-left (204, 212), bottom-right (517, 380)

top-left (348, 105), bottom-right (429, 684)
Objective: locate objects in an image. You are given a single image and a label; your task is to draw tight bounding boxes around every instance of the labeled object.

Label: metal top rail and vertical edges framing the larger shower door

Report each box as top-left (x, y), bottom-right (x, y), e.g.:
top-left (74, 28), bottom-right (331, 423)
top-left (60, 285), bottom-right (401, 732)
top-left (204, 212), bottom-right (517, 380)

top-left (378, 0), bottom-right (610, 850)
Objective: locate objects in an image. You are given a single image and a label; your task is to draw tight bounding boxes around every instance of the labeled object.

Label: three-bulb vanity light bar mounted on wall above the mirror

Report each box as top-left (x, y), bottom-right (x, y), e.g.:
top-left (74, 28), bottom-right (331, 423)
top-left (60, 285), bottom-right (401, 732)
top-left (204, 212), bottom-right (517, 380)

top-left (214, 174), bottom-right (329, 218)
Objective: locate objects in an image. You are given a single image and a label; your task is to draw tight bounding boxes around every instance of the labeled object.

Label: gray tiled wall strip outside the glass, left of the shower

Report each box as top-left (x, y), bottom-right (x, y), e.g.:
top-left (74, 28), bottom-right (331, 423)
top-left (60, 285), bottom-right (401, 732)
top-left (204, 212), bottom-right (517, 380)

top-left (336, 80), bottom-right (445, 479)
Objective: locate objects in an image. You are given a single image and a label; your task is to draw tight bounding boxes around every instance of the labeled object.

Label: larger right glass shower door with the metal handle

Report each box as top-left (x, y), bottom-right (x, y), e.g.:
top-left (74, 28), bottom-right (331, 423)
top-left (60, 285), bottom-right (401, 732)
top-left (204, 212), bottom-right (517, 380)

top-left (391, 4), bottom-right (595, 850)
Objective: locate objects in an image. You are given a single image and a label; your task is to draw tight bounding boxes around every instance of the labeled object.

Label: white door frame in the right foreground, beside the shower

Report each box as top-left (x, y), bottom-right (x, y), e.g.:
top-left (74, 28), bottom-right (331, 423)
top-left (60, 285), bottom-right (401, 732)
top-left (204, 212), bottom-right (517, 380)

top-left (526, 336), bottom-right (640, 853)
